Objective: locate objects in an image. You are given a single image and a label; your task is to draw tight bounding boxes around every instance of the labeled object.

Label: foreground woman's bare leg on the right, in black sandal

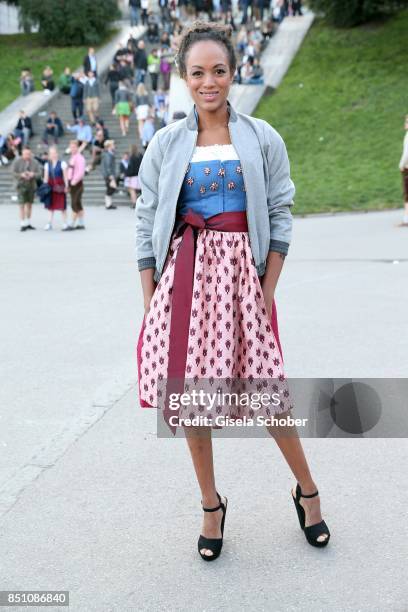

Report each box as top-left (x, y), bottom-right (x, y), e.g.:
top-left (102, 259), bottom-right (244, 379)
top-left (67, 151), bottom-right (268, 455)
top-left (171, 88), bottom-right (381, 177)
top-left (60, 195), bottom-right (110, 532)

top-left (267, 415), bottom-right (327, 542)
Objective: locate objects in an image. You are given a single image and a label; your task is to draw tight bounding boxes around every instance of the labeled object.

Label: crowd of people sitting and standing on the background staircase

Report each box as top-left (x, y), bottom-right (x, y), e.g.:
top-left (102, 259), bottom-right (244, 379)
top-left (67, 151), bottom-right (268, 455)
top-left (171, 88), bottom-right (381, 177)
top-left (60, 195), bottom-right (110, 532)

top-left (0, 0), bottom-right (301, 231)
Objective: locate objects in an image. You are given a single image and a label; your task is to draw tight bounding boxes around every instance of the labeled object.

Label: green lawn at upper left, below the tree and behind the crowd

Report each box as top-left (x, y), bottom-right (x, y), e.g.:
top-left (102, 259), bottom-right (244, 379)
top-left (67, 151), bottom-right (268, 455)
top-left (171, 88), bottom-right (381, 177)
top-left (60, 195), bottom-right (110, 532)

top-left (0, 30), bottom-right (116, 110)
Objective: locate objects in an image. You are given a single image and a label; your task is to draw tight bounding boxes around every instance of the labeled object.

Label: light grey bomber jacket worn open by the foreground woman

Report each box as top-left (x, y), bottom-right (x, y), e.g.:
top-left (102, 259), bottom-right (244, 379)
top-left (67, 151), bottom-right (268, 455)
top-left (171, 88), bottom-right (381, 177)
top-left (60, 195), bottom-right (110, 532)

top-left (135, 101), bottom-right (295, 282)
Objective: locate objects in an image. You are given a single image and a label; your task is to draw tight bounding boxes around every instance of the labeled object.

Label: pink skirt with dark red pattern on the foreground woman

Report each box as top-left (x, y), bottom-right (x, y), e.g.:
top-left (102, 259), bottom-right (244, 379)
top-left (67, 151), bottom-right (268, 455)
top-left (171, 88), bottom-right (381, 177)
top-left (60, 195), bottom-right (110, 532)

top-left (137, 228), bottom-right (291, 426)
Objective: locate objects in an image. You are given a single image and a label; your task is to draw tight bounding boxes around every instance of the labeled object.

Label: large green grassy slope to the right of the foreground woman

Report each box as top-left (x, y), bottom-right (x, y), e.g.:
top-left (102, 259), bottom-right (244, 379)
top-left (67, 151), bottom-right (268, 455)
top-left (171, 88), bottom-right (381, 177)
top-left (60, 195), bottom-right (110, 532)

top-left (254, 11), bottom-right (408, 214)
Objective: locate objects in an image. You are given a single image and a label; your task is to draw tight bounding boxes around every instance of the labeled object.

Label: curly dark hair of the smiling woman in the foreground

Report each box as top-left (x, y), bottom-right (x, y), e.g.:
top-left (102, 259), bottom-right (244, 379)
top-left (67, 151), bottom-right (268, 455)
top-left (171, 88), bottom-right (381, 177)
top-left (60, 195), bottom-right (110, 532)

top-left (175, 20), bottom-right (237, 79)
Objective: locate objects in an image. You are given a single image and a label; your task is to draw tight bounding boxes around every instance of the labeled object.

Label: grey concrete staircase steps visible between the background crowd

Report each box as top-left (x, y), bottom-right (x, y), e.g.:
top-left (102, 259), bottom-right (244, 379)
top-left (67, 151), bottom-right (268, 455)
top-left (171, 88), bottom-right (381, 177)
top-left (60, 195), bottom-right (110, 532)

top-left (0, 33), bottom-right (161, 206)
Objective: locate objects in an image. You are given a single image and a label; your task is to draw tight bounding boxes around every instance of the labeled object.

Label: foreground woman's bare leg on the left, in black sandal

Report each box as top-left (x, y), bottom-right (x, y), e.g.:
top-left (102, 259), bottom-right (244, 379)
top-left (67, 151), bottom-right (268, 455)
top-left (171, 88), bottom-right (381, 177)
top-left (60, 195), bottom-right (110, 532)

top-left (184, 427), bottom-right (225, 556)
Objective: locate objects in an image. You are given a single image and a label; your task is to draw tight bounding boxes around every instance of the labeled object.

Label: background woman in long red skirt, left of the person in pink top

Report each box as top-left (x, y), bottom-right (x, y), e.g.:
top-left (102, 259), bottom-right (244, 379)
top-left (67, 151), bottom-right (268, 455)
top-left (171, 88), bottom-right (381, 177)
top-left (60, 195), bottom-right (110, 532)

top-left (44, 146), bottom-right (68, 231)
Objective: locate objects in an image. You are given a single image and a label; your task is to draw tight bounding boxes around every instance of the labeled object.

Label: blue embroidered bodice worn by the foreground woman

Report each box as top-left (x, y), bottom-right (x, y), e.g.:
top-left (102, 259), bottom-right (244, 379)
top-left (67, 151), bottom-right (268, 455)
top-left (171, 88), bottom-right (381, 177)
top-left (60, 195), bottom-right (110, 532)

top-left (178, 159), bottom-right (246, 218)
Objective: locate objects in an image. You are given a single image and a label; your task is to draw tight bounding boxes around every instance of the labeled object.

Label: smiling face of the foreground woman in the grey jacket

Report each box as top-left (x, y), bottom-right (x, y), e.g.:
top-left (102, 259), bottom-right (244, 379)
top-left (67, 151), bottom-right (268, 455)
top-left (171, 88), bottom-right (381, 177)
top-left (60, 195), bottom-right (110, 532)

top-left (185, 40), bottom-right (234, 111)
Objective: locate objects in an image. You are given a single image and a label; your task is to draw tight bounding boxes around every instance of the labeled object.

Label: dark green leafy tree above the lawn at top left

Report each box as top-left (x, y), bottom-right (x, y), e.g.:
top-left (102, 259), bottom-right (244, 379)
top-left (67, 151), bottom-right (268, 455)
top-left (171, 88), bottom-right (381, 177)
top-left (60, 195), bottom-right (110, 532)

top-left (11, 0), bottom-right (120, 47)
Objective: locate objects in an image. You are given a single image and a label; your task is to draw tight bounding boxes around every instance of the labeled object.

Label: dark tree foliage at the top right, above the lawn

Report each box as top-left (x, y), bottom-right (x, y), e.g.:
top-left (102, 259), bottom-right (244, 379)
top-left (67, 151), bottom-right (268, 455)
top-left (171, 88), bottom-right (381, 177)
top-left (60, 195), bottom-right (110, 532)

top-left (309, 0), bottom-right (408, 27)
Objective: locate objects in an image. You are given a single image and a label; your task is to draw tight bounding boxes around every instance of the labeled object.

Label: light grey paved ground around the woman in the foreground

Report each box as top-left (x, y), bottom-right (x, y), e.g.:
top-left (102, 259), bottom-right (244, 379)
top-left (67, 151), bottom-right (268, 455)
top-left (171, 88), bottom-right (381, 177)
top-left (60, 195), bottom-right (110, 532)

top-left (0, 206), bottom-right (408, 612)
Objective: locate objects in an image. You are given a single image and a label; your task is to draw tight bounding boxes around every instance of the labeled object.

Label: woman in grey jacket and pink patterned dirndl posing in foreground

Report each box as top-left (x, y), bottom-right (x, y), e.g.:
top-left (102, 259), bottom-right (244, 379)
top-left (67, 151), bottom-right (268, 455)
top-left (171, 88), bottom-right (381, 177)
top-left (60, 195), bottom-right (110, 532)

top-left (136, 22), bottom-right (330, 561)
